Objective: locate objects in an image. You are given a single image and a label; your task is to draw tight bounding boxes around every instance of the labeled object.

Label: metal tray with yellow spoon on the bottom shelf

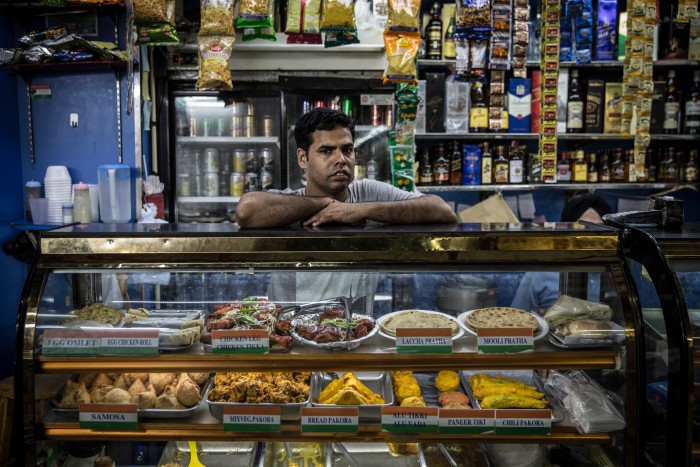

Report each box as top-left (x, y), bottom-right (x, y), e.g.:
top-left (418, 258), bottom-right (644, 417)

top-left (158, 441), bottom-right (258, 467)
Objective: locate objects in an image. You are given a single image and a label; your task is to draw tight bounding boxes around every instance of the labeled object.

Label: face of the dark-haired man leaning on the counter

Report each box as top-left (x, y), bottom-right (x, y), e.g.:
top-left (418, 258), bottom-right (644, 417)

top-left (297, 126), bottom-right (355, 197)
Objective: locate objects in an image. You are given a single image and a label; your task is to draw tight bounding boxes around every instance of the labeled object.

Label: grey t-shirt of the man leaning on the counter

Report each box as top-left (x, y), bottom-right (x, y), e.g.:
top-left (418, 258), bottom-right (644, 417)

top-left (268, 179), bottom-right (423, 314)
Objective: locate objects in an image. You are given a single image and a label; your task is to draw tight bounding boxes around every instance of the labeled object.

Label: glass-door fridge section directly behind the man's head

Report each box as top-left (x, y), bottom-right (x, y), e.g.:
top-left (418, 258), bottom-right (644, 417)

top-left (279, 76), bottom-right (396, 189)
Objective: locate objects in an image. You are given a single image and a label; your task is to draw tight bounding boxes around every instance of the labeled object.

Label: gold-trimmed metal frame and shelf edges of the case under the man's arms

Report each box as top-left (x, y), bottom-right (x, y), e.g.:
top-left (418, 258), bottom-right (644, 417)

top-left (15, 224), bottom-right (641, 466)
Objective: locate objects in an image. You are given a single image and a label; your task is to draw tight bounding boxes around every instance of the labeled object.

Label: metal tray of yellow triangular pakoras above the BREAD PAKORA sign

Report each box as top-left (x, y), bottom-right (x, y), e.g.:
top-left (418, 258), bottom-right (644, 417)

top-left (310, 371), bottom-right (394, 420)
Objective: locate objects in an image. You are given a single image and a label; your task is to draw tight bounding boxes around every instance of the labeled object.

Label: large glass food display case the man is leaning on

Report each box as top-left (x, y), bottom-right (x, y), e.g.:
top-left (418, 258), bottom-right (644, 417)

top-left (15, 224), bottom-right (643, 466)
